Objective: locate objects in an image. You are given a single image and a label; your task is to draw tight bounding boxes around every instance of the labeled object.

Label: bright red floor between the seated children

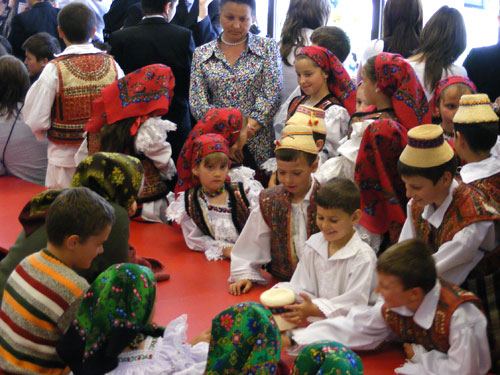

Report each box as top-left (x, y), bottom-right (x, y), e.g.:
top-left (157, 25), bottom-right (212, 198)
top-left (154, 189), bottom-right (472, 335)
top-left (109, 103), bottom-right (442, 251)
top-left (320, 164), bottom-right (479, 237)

top-left (0, 177), bottom-right (404, 375)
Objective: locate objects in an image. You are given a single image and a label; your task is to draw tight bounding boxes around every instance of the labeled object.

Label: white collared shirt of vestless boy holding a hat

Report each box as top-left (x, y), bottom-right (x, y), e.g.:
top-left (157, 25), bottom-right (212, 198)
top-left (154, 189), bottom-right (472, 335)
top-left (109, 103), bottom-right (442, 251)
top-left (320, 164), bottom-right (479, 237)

top-left (274, 232), bottom-right (377, 320)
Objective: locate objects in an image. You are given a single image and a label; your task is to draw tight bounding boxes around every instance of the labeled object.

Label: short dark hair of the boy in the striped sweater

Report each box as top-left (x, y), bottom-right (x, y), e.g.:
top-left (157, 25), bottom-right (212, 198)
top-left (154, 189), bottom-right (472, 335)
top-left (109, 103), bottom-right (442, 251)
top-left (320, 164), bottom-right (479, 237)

top-left (45, 187), bottom-right (115, 246)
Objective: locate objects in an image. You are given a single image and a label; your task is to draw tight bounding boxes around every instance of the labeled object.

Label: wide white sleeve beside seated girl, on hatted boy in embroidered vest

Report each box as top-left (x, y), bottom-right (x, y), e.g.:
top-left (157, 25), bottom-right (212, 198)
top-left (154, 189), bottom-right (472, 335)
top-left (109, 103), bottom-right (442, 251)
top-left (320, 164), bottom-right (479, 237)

top-left (229, 206), bottom-right (272, 284)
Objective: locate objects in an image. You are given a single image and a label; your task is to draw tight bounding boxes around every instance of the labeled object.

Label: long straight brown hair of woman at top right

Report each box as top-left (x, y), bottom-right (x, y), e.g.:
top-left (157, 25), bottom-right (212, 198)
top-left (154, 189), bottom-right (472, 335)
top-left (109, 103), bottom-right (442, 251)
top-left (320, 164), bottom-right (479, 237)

top-left (415, 5), bottom-right (467, 94)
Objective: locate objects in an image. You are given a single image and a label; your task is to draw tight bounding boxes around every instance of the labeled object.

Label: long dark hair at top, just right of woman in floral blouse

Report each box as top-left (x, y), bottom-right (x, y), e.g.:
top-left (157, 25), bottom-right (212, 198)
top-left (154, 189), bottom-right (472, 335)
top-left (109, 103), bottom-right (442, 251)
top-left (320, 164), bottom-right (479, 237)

top-left (280, 0), bottom-right (331, 66)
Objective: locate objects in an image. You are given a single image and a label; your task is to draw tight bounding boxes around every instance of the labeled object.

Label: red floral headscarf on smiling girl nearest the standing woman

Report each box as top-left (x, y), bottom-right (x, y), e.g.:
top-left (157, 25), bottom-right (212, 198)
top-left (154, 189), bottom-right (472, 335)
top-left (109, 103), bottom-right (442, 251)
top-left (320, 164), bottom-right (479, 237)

top-left (297, 46), bottom-right (356, 116)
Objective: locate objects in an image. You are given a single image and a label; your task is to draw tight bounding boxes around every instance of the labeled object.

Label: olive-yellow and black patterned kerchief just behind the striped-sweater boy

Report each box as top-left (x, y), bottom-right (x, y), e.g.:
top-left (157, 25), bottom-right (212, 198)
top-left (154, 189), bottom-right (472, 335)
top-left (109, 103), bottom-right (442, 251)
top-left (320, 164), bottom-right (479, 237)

top-left (71, 152), bottom-right (143, 212)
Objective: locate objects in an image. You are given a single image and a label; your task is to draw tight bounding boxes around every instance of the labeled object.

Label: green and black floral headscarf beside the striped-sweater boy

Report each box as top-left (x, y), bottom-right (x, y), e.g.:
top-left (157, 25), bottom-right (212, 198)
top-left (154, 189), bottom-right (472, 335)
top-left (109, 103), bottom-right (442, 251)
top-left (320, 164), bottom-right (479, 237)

top-left (57, 263), bottom-right (163, 375)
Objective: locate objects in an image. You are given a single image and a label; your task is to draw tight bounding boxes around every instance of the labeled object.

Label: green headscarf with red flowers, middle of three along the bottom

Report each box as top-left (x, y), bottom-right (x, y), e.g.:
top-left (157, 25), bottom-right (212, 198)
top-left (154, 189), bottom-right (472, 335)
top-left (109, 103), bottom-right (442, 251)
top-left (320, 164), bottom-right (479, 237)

top-left (205, 302), bottom-right (281, 375)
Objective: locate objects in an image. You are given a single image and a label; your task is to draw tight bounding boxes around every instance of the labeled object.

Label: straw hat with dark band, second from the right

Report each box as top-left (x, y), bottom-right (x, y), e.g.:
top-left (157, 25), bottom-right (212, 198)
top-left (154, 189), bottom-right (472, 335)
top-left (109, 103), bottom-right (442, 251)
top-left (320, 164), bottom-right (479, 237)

top-left (399, 125), bottom-right (455, 168)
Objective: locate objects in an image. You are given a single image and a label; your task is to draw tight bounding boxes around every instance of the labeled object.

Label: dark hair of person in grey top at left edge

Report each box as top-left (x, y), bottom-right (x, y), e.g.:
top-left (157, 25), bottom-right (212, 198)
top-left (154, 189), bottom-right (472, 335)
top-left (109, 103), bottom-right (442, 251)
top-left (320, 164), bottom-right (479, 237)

top-left (0, 55), bottom-right (30, 117)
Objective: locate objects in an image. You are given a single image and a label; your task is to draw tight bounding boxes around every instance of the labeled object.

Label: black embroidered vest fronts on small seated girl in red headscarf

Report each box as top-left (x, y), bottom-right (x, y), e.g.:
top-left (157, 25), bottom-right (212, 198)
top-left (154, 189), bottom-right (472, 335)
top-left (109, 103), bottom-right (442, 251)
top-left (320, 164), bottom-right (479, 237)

top-left (184, 182), bottom-right (250, 239)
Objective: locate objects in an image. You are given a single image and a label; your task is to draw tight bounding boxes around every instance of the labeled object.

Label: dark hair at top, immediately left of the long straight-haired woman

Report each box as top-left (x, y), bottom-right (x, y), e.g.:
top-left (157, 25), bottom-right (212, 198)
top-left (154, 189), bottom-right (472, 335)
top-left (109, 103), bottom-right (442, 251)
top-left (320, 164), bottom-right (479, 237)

top-left (382, 0), bottom-right (423, 57)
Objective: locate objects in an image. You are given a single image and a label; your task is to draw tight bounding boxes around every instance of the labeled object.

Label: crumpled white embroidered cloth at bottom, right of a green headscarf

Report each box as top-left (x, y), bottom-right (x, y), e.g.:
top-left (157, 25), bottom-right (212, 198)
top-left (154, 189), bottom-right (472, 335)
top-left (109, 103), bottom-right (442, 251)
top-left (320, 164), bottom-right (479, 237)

top-left (104, 315), bottom-right (209, 375)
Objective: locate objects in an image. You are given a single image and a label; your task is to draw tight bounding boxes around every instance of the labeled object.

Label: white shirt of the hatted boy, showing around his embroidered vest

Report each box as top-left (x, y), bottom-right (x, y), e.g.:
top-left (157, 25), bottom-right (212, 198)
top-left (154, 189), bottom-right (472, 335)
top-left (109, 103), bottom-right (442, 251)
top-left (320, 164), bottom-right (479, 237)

top-left (229, 178), bottom-right (314, 284)
